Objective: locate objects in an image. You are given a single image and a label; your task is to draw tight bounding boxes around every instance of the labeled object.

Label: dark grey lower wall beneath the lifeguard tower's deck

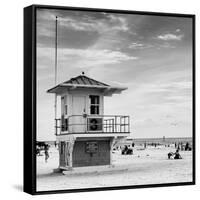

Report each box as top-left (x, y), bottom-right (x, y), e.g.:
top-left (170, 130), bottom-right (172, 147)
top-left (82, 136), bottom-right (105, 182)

top-left (73, 140), bottom-right (110, 167)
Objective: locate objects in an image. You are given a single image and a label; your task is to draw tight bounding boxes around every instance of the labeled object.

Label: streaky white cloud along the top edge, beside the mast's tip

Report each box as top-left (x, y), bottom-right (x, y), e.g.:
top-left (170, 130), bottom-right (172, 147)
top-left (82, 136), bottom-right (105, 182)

top-left (37, 10), bottom-right (129, 34)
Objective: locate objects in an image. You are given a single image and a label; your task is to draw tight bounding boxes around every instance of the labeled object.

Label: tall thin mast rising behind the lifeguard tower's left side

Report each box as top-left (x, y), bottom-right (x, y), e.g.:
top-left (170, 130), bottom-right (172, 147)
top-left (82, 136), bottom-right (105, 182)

top-left (54, 16), bottom-right (58, 135)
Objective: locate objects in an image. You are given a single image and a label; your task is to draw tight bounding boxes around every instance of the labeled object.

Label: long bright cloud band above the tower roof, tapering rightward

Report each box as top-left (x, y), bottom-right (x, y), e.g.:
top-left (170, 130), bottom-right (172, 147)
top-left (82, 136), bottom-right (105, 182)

top-left (37, 47), bottom-right (138, 68)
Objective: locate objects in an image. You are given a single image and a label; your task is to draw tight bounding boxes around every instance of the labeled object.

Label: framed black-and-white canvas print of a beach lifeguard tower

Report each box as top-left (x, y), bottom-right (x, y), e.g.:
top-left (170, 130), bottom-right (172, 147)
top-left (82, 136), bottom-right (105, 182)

top-left (24, 5), bottom-right (195, 194)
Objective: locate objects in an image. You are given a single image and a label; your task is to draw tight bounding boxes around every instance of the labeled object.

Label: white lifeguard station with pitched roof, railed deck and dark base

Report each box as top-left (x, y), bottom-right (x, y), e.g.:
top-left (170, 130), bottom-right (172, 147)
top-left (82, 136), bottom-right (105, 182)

top-left (47, 73), bottom-right (130, 170)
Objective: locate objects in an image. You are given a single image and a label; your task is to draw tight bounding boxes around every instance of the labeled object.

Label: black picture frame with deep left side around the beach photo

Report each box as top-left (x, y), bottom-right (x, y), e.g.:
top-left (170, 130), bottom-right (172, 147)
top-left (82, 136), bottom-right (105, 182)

top-left (24, 5), bottom-right (196, 195)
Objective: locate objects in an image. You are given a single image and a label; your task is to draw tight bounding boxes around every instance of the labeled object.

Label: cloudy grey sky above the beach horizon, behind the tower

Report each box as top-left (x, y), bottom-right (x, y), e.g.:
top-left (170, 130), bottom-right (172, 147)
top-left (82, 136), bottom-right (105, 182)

top-left (36, 9), bottom-right (192, 140)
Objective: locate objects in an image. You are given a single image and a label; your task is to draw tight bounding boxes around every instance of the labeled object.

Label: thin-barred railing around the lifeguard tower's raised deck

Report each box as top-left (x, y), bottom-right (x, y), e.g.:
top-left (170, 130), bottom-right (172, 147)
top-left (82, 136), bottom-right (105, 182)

top-left (56, 114), bottom-right (130, 135)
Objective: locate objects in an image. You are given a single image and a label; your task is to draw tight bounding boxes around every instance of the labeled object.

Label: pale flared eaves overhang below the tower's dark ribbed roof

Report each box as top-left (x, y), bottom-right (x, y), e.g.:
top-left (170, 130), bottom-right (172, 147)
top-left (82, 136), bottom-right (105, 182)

top-left (47, 83), bottom-right (127, 96)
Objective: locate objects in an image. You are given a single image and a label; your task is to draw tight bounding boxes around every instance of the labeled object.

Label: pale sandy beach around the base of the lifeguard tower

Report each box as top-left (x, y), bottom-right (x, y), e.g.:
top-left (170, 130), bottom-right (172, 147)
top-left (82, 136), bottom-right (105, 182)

top-left (37, 145), bottom-right (192, 191)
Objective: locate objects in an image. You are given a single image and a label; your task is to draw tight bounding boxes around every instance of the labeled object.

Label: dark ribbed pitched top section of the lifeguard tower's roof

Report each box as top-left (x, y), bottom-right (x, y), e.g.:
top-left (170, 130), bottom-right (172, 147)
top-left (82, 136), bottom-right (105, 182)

top-left (64, 75), bottom-right (109, 86)
